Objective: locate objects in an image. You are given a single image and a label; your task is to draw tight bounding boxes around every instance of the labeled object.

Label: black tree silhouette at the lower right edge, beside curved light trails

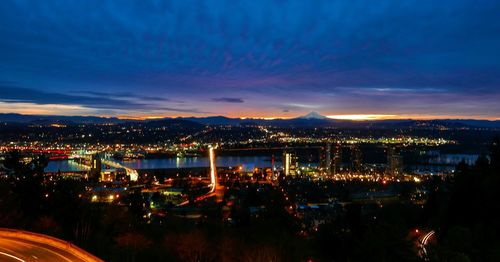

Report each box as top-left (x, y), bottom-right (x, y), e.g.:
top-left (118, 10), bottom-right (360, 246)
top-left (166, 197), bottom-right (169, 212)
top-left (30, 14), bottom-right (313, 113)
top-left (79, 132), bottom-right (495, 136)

top-left (431, 137), bottom-right (500, 261)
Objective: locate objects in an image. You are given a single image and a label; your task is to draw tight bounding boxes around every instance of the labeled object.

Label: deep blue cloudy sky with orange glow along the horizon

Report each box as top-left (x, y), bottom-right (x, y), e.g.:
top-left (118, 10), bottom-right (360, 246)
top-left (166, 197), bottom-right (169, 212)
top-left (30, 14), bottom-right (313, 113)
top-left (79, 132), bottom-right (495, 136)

top-left (0, 0), bottom-right (500, 119)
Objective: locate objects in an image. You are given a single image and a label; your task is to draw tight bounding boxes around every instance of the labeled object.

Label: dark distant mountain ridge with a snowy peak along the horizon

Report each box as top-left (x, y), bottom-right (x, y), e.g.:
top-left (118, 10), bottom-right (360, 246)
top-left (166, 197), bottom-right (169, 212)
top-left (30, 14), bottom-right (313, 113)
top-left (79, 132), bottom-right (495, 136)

top-left (0, 112), bottom-right (500, 128)
